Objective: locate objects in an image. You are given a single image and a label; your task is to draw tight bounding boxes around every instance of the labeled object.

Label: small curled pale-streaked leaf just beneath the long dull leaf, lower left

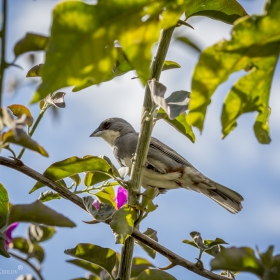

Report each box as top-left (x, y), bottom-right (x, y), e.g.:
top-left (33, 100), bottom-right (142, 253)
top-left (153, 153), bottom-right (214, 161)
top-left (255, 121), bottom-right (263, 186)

top-left (28, 224), bottom-right (56, 244)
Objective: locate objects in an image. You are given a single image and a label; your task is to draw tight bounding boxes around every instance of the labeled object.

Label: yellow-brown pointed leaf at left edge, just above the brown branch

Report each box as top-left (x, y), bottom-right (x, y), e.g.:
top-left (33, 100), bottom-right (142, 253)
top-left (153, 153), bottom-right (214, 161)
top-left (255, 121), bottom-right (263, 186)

top-left (0, 128), bottom-right (49, 157)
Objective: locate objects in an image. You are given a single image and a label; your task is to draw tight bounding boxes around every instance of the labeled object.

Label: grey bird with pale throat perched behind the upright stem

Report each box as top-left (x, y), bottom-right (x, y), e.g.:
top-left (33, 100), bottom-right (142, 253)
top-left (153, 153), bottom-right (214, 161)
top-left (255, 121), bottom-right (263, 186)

top-left (90, 118), bottom-right (244, 214)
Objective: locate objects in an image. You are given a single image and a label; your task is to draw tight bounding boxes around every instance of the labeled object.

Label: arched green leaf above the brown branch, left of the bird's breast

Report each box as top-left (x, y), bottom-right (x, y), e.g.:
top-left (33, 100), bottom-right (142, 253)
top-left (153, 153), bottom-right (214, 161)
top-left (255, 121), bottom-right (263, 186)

top-left (29, 156), bottom-right (112, 193)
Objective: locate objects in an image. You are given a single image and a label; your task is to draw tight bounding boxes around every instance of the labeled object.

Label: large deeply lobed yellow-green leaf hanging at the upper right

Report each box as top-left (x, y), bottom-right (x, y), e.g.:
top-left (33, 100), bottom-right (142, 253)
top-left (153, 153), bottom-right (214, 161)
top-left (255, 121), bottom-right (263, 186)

top-left (188, 1), bottom-right (280, 143)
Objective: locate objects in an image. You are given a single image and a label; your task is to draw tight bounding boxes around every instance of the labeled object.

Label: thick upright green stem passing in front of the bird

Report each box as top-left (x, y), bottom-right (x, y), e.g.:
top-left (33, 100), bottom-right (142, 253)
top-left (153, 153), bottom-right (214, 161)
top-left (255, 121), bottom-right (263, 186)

top-left (118, 27), bottom-right (174, 280)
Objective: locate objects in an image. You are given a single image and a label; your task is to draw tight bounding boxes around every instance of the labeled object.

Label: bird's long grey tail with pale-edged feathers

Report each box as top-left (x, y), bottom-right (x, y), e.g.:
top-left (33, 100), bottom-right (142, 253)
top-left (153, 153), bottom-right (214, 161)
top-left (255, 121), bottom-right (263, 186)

top-left (199, 180), bottom-right (244, 214)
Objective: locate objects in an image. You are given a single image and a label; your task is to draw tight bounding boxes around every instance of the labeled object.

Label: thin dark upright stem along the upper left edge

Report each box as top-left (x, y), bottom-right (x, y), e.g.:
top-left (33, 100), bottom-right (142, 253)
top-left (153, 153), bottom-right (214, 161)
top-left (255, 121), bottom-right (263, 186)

top-left (0, 0), bottom-right (7, 107)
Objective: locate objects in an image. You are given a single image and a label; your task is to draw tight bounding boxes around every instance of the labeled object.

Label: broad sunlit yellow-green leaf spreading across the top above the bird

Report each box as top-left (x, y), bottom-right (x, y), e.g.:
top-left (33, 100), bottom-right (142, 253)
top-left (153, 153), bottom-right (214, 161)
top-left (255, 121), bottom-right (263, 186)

top-left (29, 0), bottom-right (246, 102)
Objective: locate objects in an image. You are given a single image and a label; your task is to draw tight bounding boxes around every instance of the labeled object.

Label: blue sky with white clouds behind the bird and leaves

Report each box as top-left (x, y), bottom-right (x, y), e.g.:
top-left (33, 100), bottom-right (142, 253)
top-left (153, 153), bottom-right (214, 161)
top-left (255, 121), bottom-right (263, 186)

top-left (0, 0), bottom-right (280, 280)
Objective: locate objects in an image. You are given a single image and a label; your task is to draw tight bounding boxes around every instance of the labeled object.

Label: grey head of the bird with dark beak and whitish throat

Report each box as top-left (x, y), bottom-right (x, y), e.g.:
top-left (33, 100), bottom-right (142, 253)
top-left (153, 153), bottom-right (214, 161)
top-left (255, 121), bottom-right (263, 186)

top-left (90, 118), bottom-right (135, 146)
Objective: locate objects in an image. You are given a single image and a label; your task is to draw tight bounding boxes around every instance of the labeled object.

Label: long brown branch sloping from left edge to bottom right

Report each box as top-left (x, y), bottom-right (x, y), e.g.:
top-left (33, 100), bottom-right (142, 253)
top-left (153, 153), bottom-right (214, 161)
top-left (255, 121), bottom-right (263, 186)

top-left (0, 156), bottom-right (229, 280)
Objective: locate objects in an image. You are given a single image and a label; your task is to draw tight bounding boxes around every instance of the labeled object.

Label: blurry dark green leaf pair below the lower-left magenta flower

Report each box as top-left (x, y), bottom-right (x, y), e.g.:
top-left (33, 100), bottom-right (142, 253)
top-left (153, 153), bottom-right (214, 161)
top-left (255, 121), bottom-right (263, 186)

top-left (10, 237), bottom-right (45, 263)
